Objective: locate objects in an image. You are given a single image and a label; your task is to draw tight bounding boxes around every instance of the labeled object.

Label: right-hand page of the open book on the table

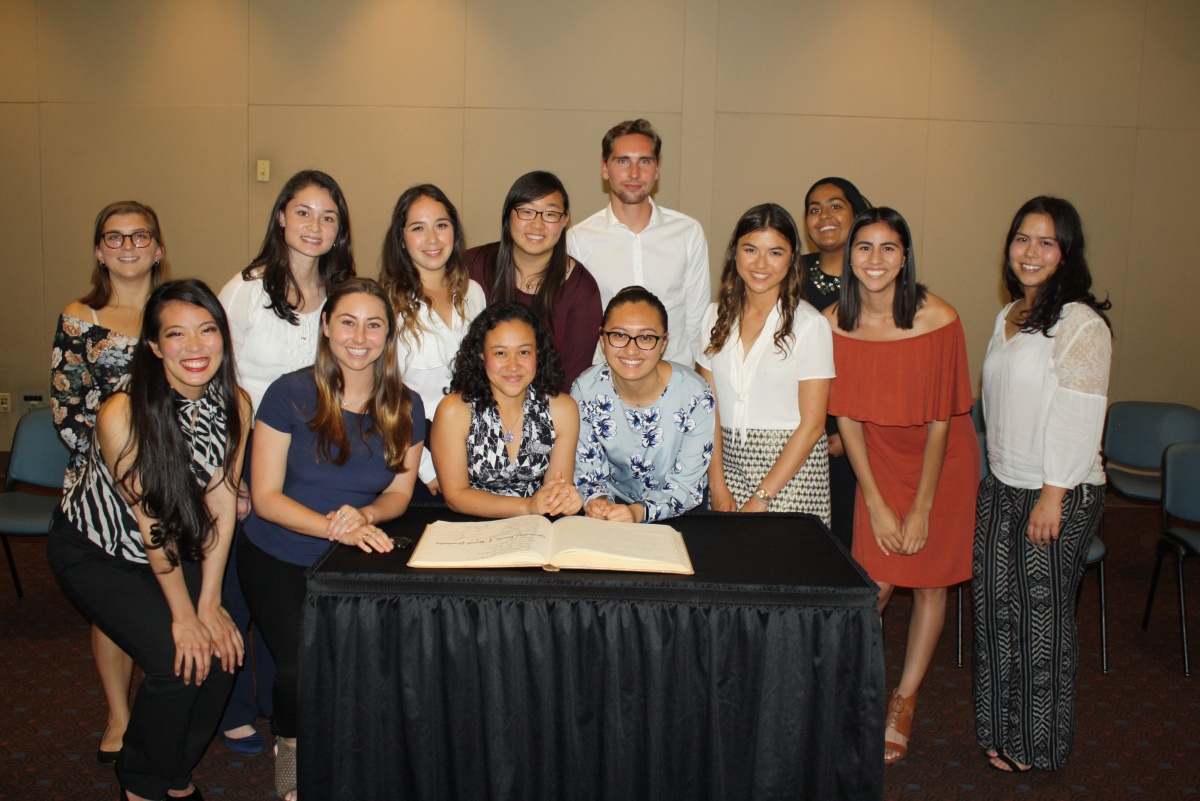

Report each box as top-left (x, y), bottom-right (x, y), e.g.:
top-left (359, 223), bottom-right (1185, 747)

top-left (551, 517), bottom-right (692, 574)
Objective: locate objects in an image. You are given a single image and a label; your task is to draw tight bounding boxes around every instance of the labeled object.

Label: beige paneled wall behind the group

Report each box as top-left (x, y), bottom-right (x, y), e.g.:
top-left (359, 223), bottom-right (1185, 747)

top-left (0, 0), bottom-right (1200, 446)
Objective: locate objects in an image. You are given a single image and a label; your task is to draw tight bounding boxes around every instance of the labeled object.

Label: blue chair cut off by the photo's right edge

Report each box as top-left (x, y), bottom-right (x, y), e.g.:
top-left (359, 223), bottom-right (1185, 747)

top-left (1141, 442), bottom-right (1200, 676)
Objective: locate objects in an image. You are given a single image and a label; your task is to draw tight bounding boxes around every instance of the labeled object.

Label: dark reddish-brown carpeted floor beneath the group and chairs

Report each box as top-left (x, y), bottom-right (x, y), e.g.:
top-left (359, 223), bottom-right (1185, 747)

top-left (0, 502), bottom-right (1200, 801)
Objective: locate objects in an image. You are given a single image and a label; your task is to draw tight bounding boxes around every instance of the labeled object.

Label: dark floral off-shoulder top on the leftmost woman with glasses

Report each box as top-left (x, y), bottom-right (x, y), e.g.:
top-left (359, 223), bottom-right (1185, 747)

top-left (50, 314), bottom-right (138, 489)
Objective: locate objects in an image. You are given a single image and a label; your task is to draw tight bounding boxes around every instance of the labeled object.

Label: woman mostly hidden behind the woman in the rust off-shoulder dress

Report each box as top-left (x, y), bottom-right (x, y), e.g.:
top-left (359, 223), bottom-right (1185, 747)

top-left (802, 177), bottom-right (871, 548)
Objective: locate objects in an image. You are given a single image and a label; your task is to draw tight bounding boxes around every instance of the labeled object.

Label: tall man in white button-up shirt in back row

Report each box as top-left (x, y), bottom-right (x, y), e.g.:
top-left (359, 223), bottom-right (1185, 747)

top-left (566, 120), bottom-right (710, 367)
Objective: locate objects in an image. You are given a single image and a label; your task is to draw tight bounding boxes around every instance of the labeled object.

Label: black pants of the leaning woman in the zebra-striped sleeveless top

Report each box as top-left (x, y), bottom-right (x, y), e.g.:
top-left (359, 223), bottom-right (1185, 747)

top-left (47, 514), bottom-right (234, 799)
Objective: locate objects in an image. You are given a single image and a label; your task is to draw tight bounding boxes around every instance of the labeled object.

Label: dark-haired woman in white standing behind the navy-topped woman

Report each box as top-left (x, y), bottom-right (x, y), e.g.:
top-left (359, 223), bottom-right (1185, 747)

top-left (221, 170), bottom-right (354, 755)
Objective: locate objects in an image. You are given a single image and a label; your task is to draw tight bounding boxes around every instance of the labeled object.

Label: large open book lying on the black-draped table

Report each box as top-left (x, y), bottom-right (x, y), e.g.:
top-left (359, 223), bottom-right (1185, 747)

top-left (408, 514), bottom-right (694, 576)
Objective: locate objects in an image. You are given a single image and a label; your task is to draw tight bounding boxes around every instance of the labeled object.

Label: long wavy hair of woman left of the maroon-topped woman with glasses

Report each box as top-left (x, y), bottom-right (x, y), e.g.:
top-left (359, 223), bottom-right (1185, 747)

top-left (379, 183), bottom-right (470, 343)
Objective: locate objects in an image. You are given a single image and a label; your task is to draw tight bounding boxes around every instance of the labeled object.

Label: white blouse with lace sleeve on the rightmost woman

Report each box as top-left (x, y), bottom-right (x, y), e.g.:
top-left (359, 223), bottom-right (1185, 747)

top-left (983, 298), bottom-right (1112, 489)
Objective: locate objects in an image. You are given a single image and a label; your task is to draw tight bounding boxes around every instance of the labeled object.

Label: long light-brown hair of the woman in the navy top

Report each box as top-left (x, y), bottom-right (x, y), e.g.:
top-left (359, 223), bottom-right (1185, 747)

top-left (308, 277), bottom-right (413, 472)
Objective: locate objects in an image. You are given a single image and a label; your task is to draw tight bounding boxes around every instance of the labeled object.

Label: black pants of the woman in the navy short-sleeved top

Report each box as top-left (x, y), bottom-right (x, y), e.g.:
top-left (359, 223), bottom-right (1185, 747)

top-left (236, 531), bottom-right (307, 737)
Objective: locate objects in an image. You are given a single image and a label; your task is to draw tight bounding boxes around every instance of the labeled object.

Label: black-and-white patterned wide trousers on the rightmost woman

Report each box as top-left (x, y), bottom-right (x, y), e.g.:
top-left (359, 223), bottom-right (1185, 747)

top-left (972, 476), bottom-right (1104, 770)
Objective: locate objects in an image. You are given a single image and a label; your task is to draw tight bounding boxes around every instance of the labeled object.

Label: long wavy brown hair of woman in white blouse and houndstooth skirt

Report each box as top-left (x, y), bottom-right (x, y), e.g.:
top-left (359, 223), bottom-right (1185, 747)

top-left (704, 203), bottom-right (804, 356)
